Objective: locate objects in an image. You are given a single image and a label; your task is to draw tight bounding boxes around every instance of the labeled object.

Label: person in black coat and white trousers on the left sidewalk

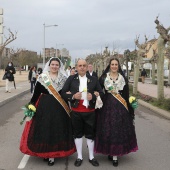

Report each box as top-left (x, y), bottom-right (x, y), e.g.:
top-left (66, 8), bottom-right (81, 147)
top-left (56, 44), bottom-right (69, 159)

top-left (5, 62), bottom-right (16, 93)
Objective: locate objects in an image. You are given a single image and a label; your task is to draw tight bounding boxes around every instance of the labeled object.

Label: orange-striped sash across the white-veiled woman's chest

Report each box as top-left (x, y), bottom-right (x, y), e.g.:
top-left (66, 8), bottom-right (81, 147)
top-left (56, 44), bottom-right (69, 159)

top-left (41, 73), bottom-right (71, 117)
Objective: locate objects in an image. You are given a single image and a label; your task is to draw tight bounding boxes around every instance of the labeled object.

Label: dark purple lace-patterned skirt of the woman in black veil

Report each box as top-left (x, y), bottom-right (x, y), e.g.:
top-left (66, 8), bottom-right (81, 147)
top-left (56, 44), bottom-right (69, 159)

top-left (95, 93), bottom-right (138, 156)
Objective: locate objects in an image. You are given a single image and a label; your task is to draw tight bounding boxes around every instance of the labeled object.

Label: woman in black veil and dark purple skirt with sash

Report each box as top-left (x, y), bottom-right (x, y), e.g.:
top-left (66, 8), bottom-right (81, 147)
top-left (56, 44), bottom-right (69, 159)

top-left (95, 58), bottom-right (138, 166)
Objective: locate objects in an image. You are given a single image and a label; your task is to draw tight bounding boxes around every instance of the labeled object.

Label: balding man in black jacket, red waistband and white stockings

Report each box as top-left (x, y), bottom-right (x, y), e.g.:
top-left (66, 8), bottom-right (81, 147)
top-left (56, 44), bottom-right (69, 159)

top-left (61, 59), bottom-right (104, 167)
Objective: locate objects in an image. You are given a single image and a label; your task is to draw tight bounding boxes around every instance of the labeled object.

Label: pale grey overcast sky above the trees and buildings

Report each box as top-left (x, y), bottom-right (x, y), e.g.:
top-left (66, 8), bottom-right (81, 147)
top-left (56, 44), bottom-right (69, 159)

top-left (0, 0), bottom-right (170, 58)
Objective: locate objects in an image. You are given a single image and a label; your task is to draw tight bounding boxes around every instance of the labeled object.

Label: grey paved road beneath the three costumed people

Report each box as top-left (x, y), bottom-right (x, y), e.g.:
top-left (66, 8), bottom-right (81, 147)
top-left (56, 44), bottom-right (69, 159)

top-left (0, 94), bottom-right (170, 170)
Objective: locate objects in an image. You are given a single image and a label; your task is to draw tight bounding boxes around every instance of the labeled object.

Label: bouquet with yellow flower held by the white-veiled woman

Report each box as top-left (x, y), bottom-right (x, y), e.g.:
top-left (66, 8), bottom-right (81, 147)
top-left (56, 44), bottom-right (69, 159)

top-left (20, 104), bottom-right (36, 125)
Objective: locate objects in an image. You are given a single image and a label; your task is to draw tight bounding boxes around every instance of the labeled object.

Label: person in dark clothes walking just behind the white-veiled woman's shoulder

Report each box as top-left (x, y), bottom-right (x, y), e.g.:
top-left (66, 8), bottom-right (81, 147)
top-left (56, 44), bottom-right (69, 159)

top-left (28, 66), bottom-right (37, 94)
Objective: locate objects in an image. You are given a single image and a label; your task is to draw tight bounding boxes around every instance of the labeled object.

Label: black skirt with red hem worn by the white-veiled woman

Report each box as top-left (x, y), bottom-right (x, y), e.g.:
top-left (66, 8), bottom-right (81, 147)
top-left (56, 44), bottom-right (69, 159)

top-left (20, 95), bottom-right (75, 158)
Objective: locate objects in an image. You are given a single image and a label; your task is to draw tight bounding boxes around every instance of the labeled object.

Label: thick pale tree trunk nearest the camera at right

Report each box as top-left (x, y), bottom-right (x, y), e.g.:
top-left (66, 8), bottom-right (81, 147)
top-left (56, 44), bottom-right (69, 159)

top-left (157, 36), bottom-right (166, 99)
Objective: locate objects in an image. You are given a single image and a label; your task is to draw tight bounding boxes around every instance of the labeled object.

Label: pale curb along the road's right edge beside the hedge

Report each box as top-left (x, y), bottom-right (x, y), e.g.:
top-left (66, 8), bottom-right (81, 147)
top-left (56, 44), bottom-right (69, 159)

top-left (138, 99), bottom-right (170, 120)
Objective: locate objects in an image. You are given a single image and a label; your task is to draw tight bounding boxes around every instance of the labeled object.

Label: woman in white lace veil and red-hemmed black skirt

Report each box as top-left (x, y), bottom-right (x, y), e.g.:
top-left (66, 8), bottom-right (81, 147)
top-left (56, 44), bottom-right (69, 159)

top-left (20, 58), bottom-right (75, 166)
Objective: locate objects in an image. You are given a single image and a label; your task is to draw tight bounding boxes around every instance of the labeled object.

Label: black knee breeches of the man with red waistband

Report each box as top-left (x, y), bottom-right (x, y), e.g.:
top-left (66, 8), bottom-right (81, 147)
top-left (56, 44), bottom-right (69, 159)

top-left (71, 111), bottom-right (96, 140)
